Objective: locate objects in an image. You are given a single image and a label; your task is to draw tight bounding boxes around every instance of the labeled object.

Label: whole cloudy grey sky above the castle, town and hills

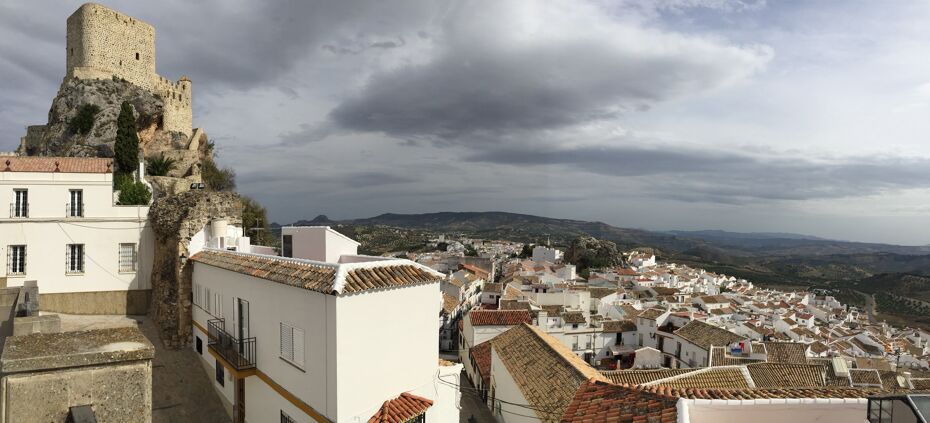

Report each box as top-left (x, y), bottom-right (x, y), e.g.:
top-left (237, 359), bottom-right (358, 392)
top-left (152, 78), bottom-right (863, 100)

top-left (0, 0), bottom-right (930, 245)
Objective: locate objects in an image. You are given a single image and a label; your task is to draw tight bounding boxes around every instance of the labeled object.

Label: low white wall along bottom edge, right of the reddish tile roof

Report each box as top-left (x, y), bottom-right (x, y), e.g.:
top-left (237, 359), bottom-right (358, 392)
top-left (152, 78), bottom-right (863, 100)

top-left (678, 398), bottom-right (868, 423)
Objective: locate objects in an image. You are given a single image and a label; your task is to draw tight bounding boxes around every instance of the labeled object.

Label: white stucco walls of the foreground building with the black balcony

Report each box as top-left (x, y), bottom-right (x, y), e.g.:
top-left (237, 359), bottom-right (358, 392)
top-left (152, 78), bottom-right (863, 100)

top-left (193, 263), bottom-right (448, 422)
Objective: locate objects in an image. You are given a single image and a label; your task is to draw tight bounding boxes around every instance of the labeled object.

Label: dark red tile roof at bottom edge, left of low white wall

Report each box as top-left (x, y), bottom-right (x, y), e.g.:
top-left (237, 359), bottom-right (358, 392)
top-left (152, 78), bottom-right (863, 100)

top-left (562, 381), bottom-right (678, 423)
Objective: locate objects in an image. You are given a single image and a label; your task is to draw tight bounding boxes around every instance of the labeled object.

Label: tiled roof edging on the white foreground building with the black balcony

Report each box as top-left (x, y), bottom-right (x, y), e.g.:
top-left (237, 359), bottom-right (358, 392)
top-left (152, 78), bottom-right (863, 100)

top-left (190, 250), bottom-right (443, 295)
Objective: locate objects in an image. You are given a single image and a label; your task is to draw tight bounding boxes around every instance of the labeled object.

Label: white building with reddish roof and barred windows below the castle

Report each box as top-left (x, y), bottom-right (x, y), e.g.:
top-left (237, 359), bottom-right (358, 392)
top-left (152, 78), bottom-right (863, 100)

top-left (0, 156), bottom-right (153, 308)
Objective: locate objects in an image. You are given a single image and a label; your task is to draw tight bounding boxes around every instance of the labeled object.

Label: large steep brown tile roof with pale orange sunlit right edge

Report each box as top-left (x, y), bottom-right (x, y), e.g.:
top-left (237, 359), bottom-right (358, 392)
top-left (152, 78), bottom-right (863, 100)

top-left (491, 324), bottom-right (607, 422)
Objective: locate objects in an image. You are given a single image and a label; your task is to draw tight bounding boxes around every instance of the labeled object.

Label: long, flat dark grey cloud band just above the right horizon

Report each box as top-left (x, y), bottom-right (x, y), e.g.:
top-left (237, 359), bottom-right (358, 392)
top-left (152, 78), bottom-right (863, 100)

top-left (467, 146), bottom-right (930, 204)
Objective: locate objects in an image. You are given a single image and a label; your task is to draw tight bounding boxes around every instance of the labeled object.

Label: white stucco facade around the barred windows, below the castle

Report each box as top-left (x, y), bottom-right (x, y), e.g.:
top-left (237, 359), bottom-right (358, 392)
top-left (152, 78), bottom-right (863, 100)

top-left (0, 172), bottom-right (154, 294)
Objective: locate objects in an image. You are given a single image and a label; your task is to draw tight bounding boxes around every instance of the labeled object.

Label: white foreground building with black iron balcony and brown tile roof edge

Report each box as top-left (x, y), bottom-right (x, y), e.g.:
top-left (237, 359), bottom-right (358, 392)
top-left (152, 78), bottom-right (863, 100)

top-left (190, 230), bottom-right (461, 422)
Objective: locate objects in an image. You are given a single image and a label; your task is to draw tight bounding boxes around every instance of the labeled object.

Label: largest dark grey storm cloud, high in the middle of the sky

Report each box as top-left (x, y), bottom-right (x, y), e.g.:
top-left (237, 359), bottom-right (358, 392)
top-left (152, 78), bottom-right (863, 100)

top-left (331, 3), bottom-right (771, 141)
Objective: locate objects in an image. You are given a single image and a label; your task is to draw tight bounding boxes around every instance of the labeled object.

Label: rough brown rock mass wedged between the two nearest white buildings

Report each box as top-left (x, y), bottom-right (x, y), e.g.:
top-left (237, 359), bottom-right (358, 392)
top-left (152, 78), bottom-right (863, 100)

top-left (149, 190), bottom-right (242, 348)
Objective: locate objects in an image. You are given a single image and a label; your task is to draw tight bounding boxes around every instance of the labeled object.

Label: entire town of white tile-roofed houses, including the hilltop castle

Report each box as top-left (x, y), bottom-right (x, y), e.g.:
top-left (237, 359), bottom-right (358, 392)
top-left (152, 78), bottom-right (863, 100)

top-left (0, 4), bottom-right (930, 423)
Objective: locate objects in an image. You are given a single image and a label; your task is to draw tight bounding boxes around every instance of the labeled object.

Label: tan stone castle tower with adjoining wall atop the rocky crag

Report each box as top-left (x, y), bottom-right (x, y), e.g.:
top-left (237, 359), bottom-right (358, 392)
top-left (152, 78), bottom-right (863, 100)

top-left (65, 3), bottom-right (193, 138)
